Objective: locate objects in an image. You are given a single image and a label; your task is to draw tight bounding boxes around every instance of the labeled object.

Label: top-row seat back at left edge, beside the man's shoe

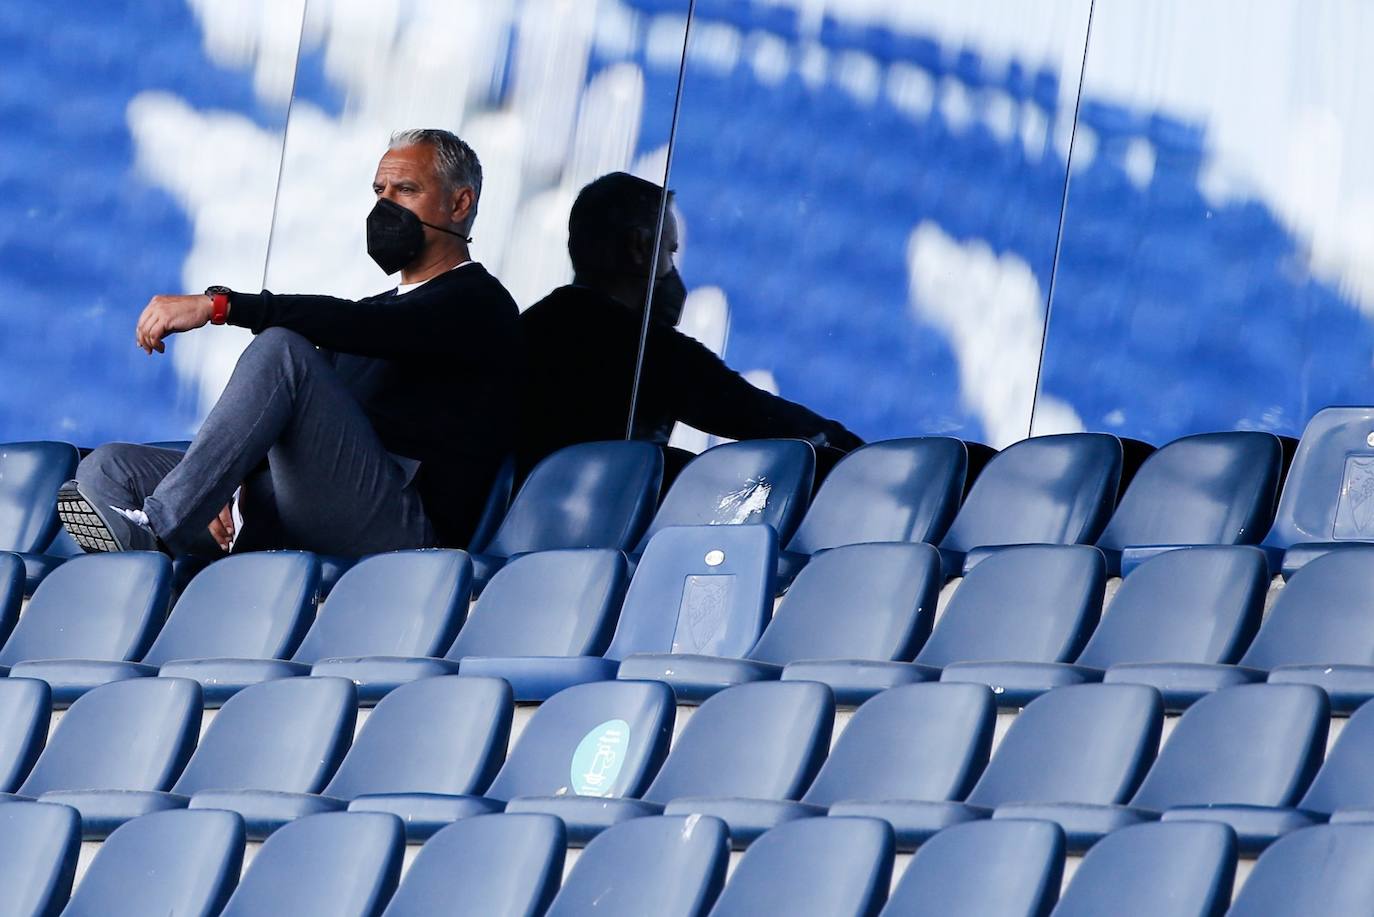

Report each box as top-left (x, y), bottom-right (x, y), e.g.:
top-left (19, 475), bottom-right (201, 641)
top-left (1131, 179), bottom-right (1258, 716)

top-left (0, 443), bottom-right (81, 551)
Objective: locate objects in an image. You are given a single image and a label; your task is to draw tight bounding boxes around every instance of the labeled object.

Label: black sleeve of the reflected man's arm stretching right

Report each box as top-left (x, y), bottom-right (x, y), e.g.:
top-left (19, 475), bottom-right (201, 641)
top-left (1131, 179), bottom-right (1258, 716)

top-left (644, 331), bottom-right (863, 451)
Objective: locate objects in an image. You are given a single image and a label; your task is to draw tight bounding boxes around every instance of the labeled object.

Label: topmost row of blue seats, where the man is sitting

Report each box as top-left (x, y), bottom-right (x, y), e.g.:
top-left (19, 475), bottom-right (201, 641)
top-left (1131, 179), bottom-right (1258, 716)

top-left (10, 408), bottom-right (1374, 591)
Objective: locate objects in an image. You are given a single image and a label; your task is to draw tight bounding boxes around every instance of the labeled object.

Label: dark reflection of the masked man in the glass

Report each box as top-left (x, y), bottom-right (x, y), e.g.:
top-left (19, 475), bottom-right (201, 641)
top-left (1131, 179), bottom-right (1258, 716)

top-left (521, 172), bottom-right (863, 470)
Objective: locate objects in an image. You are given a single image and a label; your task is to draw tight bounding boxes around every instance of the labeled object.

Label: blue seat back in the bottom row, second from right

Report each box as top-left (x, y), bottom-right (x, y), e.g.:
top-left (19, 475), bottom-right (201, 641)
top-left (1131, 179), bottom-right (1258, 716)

top-left (1054, 822), bottom-right (1235, 917)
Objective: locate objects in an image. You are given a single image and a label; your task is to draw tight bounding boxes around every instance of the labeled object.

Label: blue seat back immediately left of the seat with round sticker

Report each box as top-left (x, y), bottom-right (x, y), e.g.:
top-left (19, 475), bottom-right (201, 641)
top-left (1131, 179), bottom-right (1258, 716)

top-left (324, 675), bottom-right (515, 799)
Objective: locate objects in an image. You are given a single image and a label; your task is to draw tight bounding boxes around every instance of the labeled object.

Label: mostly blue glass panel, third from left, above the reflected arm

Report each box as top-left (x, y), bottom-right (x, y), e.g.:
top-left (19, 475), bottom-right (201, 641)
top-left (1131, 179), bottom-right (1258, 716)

top-left (637, 0), bottom-right (1090, 450)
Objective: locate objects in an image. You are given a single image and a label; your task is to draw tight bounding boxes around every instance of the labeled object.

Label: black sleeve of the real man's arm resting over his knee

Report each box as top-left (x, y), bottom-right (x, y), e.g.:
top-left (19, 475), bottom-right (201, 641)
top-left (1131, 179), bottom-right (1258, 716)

top-left (228, 270), bottom-right (515, 357)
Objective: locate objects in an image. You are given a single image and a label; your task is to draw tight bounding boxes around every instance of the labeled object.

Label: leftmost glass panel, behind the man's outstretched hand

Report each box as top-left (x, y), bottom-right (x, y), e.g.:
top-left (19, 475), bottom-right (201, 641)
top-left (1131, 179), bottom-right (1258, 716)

top-left (0, 0), bottom-right (304, 444)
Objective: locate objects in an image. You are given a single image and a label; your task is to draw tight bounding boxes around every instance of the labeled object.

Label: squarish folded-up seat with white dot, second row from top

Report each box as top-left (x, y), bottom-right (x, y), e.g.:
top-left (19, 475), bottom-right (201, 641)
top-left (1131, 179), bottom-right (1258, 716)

top-left (606, 525), bottom-right (778, 660)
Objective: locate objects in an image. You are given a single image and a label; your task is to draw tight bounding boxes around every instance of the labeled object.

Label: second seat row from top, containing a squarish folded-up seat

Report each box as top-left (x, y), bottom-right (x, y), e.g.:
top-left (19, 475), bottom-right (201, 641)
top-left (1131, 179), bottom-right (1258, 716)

top-left (8, 525), bottom-right (1374, 714)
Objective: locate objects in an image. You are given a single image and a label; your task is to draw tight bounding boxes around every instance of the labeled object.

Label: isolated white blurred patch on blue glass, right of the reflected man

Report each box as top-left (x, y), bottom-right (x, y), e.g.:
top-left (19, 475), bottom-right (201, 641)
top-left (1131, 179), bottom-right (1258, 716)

top-left (907, 215), bottom-right (1083, 448)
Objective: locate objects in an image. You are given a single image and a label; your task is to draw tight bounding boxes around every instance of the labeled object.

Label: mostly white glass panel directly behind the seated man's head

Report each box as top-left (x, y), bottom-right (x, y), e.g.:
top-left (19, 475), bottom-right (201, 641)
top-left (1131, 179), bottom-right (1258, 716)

top-left (258, 0), bottom-right (687, 470)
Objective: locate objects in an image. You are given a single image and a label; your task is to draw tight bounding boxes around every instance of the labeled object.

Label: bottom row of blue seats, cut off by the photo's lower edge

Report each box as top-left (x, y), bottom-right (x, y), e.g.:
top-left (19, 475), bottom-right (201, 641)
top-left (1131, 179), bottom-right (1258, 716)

top-left (8, 803), bottom-right (1374, 917)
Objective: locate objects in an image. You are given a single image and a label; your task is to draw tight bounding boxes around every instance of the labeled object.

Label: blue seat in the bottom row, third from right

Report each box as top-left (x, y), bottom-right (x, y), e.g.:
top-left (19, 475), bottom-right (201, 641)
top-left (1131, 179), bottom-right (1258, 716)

top-left (882, 821), bottom-right (1065, 917)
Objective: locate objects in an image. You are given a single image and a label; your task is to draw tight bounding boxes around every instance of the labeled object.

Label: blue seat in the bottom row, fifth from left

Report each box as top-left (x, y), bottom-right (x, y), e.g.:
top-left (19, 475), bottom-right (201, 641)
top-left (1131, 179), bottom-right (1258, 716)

top-left (548, 817), bottom-right (730, 917)
